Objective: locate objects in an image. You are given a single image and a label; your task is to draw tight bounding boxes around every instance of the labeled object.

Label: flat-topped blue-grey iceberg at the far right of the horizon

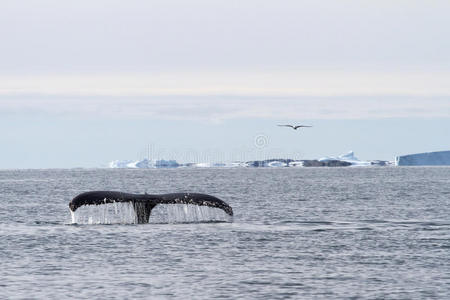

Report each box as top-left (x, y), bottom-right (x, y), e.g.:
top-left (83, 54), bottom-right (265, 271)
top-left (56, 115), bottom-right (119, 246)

top-left (395, 151), bottom-right (450, 166)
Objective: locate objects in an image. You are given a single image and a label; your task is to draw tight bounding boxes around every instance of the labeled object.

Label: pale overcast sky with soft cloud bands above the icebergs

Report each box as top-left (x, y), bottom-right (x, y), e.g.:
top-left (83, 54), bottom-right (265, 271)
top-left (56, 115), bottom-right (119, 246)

top-left (0, 0), bottom-right (450, 168)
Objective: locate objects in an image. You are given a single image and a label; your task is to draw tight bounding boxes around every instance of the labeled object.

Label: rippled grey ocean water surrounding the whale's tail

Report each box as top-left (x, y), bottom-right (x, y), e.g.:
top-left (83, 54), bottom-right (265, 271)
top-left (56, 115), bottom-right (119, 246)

top-left (0, 167), bottom-right (450, 299)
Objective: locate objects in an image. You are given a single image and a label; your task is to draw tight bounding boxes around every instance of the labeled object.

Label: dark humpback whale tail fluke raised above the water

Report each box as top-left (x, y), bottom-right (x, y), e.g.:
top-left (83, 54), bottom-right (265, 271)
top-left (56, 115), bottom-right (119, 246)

top-left (69, 191), bottom-right (233, 224)
